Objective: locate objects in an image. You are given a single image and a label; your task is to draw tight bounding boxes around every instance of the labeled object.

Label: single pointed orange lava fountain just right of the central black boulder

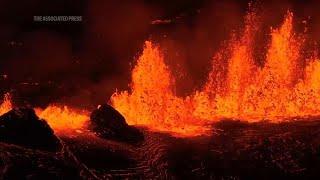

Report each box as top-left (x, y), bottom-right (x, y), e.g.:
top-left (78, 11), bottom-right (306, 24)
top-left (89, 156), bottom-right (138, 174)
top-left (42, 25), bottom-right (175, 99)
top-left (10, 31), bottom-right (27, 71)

top-left (111, 41), bottom-right (209, 135)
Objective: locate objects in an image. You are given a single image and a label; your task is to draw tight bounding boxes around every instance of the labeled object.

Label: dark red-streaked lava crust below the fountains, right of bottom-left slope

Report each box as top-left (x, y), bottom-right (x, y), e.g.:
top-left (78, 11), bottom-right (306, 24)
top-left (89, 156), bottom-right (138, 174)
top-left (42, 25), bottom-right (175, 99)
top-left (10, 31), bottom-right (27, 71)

top-left (63, 120), bottom-right (320, 179)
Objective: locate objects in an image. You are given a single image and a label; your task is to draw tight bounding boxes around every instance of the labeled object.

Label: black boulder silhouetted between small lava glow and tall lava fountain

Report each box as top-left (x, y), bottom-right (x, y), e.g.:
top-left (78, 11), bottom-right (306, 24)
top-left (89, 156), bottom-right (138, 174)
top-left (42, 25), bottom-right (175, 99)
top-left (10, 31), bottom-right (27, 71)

top-left (90, 104), bottom-right (144, 143)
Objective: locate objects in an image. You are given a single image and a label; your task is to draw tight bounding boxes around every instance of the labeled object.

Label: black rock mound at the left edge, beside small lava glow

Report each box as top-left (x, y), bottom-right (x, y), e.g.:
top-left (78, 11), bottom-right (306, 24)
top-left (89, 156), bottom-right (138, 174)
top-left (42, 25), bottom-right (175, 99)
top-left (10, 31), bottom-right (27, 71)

top-left (0, 108), bottom-right (61, 151)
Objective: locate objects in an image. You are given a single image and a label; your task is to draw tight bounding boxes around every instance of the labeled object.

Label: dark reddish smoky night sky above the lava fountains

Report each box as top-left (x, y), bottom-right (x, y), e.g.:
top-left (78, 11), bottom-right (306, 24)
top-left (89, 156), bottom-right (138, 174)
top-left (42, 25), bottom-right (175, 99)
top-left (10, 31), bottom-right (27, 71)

top-left (0, 0), bottom-right (320, 105)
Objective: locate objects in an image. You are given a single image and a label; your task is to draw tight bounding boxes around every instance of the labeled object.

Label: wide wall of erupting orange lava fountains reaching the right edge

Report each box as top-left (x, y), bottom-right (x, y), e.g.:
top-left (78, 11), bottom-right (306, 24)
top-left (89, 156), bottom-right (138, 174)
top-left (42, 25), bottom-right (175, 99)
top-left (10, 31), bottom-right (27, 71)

top-left (111, 12), bottom-right (320, 136)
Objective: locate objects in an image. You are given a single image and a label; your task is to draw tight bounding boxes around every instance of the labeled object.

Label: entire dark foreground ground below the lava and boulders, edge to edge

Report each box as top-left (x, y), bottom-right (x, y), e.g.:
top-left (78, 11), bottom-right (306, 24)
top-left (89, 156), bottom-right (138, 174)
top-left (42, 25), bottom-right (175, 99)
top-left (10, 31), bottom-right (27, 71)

top-left (0, 119), bottom-right (320, 179)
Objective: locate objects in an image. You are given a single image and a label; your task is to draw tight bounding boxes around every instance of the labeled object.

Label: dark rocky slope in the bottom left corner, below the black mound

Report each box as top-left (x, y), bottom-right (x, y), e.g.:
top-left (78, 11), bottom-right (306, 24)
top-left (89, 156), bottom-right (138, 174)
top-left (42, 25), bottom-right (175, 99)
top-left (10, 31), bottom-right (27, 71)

top-left (0, 142), bottom-right (85, 180)
